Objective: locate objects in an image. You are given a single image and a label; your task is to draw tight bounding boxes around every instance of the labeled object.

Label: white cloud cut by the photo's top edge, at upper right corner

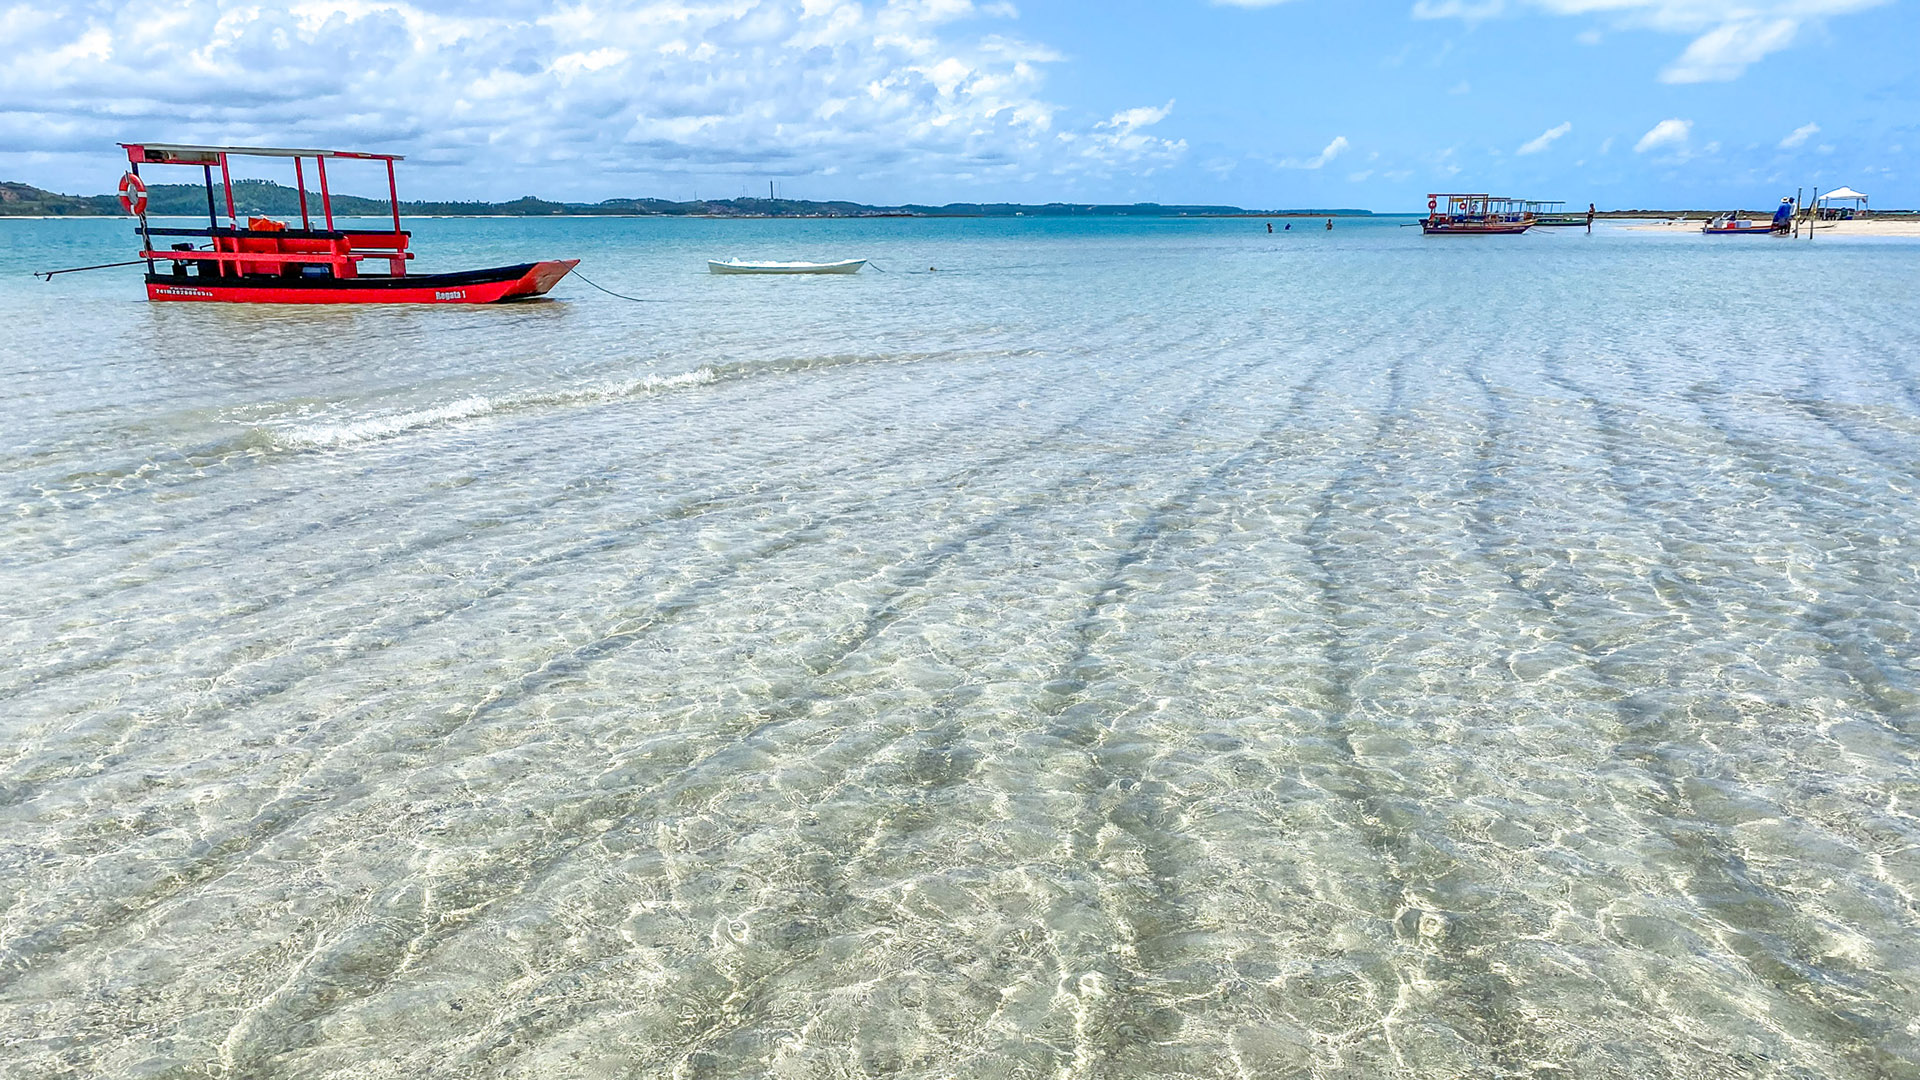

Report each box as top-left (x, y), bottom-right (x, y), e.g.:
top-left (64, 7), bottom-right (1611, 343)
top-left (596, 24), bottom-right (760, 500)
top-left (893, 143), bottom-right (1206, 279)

top-left (1413, 0), bottom-right (1891, 83)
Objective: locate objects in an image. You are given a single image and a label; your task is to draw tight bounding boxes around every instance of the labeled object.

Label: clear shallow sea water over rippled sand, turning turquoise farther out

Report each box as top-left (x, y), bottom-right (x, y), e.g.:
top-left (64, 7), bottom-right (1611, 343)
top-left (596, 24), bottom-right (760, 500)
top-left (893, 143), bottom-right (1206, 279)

top-left (0, 214), bottom-right (1920, 1080)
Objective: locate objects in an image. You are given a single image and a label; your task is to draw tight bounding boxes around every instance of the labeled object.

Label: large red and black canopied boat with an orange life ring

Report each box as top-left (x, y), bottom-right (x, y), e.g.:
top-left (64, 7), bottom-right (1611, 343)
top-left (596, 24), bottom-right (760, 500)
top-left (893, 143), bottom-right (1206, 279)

top-left (119, 142), bottom-right (580, 304)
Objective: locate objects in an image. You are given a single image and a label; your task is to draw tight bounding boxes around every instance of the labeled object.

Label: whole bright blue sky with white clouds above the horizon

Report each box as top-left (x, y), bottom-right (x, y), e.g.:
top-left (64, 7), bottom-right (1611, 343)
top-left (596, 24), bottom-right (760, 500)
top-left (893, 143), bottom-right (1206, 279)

top-left (0, 0), bottom-right (1920, 209)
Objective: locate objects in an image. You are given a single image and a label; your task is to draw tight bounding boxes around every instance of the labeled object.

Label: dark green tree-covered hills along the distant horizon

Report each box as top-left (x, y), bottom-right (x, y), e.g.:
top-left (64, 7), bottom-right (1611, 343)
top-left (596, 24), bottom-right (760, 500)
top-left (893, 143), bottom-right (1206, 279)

top-left (0, 181), bottom-right (1369, 221)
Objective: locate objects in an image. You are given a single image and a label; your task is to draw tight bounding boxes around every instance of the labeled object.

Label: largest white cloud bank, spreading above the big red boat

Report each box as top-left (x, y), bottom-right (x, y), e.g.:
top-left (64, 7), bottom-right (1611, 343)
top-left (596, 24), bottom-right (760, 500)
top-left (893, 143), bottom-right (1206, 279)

top-left (0, 0), bottom-right (1187, 196)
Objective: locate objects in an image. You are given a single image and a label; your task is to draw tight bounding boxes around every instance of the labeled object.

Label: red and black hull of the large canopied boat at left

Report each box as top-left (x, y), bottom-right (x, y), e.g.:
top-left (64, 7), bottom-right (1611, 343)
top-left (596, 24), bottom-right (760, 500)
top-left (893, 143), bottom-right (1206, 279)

top-left (146, 259), bottom-right (580, 304)
